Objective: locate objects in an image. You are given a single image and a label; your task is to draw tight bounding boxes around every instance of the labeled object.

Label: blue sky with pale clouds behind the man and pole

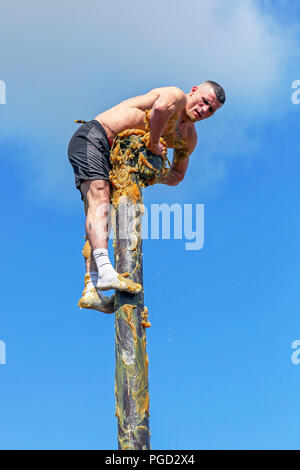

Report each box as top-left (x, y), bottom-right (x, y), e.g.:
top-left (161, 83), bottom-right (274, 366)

top-left (0, 0), bottom-right (300, 449)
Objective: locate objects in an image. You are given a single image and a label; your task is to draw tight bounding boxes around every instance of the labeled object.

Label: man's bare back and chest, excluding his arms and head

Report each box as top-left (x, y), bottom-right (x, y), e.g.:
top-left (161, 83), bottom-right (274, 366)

top-left (95, 87), bottom-right (195, 148)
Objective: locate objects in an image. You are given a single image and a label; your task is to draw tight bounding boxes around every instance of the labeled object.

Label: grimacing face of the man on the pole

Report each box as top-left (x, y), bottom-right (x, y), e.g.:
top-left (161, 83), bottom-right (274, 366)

top-left (185, 83), bottom-right (222, 122)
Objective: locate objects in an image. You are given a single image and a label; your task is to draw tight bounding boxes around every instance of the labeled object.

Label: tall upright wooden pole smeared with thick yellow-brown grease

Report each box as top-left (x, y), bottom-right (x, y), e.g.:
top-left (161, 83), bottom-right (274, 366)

top-left (110, 130), bottom-right (165, 450)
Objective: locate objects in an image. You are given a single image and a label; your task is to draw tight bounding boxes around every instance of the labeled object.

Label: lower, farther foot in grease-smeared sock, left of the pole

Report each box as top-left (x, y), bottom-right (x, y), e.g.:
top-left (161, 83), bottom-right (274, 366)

top-left (78, 274), bottom-right (115, 313)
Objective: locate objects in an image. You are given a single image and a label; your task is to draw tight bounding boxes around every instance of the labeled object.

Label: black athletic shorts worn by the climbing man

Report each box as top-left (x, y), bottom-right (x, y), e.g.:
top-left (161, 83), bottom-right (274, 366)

top-left (68, 119), bottom-right (112, 195)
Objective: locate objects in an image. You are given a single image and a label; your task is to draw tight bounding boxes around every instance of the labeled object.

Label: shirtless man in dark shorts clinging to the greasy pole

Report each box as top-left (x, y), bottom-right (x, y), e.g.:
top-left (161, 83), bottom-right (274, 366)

top-left (68, 81), bottom-right (225, 313)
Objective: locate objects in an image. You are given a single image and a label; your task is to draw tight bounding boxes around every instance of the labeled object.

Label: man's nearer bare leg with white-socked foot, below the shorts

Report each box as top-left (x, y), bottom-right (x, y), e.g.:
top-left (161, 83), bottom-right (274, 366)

top-left (80, 180), bottom-right (142, 294)
